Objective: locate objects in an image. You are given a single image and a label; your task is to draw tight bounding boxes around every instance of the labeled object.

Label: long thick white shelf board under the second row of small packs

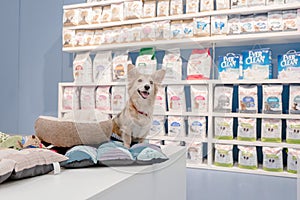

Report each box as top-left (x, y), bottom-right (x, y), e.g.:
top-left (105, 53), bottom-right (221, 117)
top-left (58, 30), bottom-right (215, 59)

top-left (62, 31), bottom-right (300, 53)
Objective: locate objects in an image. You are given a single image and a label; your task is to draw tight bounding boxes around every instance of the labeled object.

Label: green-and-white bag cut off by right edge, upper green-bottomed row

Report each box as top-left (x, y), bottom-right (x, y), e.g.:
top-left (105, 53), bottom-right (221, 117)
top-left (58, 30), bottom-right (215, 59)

top-left (286, 119), bottom-right (300, 144)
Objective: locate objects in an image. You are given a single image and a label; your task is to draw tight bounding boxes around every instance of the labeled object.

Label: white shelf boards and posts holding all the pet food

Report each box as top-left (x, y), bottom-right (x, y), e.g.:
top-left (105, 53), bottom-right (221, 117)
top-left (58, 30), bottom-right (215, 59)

top-left (58, 1), bottom-right (300, 178)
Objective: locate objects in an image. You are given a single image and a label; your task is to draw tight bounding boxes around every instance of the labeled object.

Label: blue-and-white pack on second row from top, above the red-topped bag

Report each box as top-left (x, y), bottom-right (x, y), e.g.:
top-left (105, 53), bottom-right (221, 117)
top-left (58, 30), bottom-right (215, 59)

top-left (194, 16), bottom-right (210, 36)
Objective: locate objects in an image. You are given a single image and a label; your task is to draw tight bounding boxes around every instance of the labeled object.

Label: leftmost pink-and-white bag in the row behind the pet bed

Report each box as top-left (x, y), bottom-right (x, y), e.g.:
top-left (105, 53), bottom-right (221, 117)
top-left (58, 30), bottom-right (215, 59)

top-left (62, 86), bottom-right (79, 110)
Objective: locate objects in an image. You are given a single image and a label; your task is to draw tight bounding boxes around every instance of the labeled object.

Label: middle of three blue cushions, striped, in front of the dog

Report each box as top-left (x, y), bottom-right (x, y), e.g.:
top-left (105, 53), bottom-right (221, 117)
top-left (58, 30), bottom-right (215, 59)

top-left (97, 141), bottom-right (134, 166)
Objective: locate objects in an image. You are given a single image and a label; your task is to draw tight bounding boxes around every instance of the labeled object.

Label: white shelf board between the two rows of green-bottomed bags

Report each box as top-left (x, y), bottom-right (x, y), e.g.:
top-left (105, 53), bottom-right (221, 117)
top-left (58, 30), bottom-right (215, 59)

top-left (212, 138), bottom-right (300, 149)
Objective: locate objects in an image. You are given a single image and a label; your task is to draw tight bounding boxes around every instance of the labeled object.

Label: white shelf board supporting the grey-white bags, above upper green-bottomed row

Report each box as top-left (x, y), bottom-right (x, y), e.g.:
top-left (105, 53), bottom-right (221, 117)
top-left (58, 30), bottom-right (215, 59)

top-left (212, 112), bottom-right (300, 119)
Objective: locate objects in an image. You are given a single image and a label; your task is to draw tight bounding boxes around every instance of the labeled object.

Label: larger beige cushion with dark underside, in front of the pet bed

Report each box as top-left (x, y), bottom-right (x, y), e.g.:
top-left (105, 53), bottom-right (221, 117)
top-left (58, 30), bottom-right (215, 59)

top-left (4, 148), bottom-right (68, 179)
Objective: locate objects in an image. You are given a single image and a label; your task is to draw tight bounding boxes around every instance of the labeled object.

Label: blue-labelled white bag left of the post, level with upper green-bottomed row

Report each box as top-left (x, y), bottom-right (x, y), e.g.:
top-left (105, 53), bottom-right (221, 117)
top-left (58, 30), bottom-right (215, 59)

top-left (188, 116), bottom-right (206, 139)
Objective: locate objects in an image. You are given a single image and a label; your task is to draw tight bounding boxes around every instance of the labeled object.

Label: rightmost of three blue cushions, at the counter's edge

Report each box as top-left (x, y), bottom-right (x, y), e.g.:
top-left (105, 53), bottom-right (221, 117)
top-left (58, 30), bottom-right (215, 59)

top-left (129, 143), bottom-right (168, 165)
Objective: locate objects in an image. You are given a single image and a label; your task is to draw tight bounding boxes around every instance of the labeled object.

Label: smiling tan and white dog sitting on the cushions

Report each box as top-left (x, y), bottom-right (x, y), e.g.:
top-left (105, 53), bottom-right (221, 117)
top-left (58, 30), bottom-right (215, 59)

top-left (112, 65), bottom-right (165, 148)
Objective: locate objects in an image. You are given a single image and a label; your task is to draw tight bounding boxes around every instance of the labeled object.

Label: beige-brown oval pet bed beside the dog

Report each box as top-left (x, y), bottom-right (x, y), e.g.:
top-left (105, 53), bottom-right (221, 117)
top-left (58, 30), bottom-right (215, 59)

top-left (35, 116), bottom-right (112, 147)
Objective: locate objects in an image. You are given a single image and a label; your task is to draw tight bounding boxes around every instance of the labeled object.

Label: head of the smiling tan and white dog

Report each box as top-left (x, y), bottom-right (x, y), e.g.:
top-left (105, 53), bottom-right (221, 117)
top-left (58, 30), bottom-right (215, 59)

top-left (128, 65), bottom-right (166, 101)
